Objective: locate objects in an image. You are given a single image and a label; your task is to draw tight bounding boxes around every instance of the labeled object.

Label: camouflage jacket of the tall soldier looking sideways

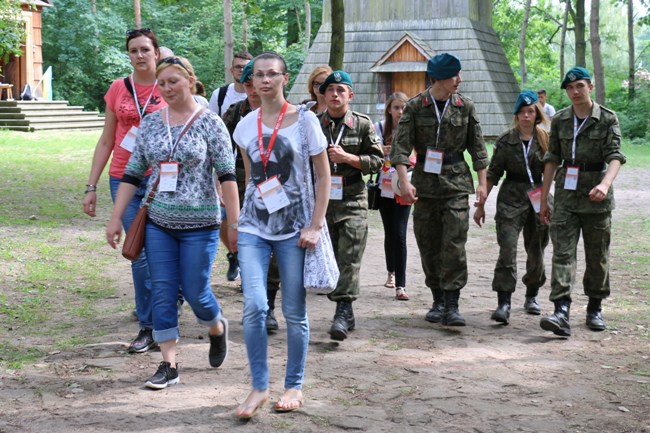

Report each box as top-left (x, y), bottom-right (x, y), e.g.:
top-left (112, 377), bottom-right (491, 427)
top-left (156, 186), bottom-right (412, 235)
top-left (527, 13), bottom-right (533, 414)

top-left (390, 89), bottom-right (489, 198)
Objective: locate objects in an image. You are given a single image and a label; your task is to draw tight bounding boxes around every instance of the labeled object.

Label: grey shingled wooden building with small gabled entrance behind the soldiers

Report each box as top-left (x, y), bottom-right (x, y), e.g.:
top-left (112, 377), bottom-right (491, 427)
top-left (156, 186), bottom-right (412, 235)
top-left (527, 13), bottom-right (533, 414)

top-left (289, 0), bottom-right (519, 137)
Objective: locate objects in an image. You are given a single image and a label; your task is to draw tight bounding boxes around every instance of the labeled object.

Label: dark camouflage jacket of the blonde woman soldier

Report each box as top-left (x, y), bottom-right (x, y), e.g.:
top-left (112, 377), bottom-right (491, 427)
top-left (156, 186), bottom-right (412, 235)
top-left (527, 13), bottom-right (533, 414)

top-left (487, 128), bottom-right (544, 218)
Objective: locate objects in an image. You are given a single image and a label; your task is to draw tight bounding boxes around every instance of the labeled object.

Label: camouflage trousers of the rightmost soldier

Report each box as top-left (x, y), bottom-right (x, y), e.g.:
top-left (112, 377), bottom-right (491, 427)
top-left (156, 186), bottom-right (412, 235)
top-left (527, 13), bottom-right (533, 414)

top-left (550, 206), bottom-right (612, 301)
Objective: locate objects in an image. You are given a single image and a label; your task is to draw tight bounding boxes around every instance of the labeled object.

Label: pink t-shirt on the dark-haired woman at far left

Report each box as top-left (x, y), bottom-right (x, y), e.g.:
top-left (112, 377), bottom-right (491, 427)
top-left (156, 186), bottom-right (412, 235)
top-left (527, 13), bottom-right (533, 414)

top-left (104, 78), bottom-right (167, 179)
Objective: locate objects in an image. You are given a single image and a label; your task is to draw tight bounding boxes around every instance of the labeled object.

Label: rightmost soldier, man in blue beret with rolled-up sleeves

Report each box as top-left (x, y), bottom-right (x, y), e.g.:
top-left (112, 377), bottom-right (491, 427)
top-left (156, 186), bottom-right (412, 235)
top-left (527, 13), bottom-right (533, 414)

top-left (540, 67), bottom-right (626, 337)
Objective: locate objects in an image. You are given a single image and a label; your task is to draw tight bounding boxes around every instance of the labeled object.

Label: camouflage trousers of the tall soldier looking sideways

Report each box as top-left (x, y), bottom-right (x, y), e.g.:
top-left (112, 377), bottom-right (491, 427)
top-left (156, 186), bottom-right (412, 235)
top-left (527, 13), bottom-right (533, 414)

top-left (413, 195), bottom-right (469, 293)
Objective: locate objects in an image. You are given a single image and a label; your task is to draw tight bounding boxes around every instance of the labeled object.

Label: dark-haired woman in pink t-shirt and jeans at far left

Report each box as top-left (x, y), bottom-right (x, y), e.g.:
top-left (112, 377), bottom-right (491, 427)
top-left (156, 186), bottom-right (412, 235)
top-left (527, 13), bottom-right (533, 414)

top-left (83, 29), bottom-right (167, 353)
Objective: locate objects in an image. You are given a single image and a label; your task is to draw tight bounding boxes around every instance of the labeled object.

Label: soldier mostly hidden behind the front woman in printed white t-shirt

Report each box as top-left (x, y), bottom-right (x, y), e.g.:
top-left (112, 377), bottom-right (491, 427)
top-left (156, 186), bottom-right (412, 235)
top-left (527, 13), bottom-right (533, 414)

top-left (223, 60), bottom-right (280, 333)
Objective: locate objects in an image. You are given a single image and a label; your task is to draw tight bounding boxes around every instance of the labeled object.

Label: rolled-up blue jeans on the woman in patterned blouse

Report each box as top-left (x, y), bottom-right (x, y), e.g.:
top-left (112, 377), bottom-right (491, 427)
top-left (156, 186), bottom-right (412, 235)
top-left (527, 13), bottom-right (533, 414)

top-left (144, 222), bottom-right (221, 343)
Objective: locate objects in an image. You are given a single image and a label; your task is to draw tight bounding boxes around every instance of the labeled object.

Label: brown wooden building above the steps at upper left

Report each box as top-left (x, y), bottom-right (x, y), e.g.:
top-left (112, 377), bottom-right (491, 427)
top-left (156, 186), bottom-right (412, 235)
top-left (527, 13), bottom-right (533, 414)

top-left (0, 0), bottom-right (53, 99)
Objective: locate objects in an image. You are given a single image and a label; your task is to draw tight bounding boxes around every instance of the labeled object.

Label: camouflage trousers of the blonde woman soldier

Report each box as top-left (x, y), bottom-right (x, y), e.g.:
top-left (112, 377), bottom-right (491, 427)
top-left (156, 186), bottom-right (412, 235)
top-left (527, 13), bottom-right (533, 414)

top-left (492, 207), bottom-right (549, 296)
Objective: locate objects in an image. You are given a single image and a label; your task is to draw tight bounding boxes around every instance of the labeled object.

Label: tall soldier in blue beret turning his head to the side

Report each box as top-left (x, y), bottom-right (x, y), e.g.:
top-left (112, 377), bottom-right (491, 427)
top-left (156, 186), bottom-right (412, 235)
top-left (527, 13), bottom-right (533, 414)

top-left (390, 53), bottom-right (489, 326)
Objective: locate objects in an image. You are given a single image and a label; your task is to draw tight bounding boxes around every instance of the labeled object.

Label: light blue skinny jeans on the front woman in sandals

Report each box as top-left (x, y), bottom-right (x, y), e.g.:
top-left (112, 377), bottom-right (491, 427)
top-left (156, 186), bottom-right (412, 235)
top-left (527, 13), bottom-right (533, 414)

top-left (237, 233), bottom-right (309, 391)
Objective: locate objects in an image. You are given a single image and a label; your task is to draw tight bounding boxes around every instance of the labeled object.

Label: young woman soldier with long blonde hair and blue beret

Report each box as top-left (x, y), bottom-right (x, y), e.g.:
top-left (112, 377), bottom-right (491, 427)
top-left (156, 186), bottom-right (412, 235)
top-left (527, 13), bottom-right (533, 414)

top-left (474, 90), bottom-right (552, 325)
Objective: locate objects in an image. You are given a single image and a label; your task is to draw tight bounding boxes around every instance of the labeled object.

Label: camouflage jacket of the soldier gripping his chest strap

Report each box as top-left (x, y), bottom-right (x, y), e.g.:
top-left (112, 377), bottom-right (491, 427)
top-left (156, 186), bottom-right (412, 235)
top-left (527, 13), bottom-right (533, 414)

top-left (318, 110), bottom-right (384, 198)
